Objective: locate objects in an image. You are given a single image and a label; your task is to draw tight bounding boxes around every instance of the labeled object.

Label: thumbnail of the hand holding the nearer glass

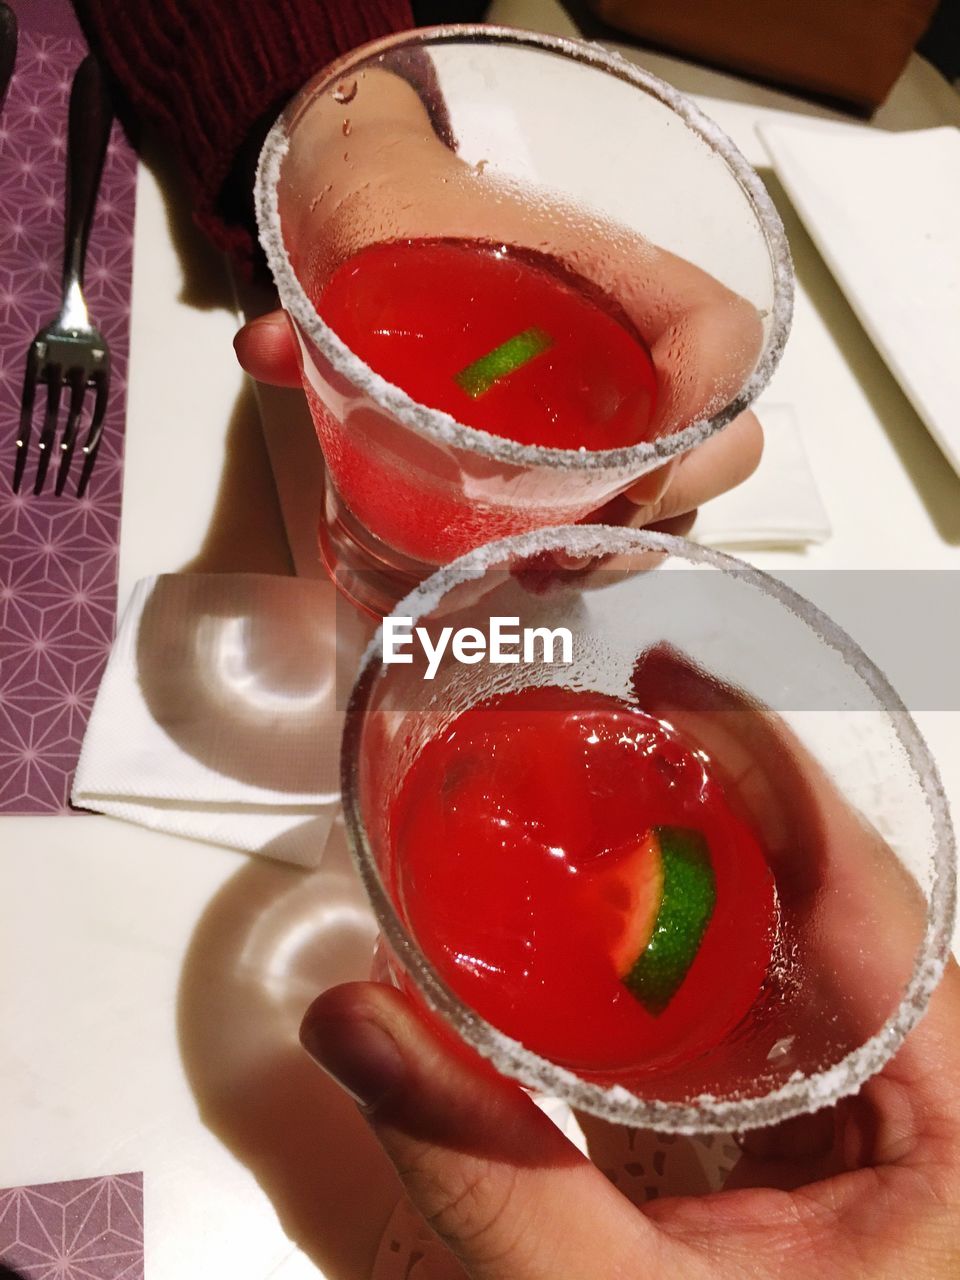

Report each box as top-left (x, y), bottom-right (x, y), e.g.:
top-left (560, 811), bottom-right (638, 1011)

top-left (300, 1006), bottom-right (404, 1111)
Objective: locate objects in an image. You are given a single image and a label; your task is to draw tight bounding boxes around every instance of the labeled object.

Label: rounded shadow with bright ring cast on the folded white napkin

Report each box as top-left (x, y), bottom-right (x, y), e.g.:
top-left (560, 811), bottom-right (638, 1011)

top-left (136, 573), bottom-right (369, 798)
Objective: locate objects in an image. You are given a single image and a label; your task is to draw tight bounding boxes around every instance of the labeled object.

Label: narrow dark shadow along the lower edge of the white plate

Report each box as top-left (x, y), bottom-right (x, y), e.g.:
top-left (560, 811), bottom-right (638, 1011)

top-left (759, 169), bottom-right (960, 545)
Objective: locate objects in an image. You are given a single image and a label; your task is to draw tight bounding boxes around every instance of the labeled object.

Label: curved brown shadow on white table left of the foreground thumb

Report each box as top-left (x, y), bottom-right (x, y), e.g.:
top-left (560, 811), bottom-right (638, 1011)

top-left (178, 827), bottom-right (401, 1280)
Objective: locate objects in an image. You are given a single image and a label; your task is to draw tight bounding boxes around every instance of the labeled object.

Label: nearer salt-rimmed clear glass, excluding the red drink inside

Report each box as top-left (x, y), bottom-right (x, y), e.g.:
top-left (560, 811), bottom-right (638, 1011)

top-left (342, 525), bottom-right (955, 1133)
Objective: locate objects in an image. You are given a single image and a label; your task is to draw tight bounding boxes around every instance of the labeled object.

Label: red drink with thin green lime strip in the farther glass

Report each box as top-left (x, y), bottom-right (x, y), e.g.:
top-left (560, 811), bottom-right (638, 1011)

top-left (306, 239), bottom-right (657, 576)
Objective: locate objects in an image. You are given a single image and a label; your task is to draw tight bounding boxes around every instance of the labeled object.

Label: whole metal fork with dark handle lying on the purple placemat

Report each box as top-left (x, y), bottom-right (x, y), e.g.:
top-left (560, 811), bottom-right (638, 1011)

top-left (13, 56), bottom-right (113, 498)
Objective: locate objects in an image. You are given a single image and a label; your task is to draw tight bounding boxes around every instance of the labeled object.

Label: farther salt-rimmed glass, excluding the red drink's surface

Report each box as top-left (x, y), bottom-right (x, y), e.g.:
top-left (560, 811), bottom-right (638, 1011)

top-left (256, 27), bottom-right (792, 614)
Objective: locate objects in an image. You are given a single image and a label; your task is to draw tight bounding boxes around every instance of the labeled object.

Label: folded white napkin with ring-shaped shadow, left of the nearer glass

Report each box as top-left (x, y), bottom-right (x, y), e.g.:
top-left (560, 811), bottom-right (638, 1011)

top-left (72, 573), bottom-right (365, 867)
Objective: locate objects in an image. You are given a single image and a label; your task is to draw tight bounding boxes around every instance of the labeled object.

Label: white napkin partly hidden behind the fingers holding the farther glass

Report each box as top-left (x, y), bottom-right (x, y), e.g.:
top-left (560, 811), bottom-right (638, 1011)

top-left (690, 404), bottom-right (831, 548)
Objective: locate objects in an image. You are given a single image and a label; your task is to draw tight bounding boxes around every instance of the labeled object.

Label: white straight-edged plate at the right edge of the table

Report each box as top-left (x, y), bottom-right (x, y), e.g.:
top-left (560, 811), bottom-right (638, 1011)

top-left (758, 120), bottom-right (960, 475)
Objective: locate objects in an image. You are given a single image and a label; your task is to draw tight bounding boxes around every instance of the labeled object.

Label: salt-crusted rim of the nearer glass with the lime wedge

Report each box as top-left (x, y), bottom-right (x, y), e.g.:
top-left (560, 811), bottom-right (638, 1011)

top-left (340, 525), bottom-right (956, 1133)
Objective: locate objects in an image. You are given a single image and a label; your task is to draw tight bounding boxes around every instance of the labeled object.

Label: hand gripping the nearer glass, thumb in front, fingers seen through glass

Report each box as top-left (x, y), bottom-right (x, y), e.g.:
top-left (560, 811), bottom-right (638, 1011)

top-left (301, 649), bottom-right (960, 1280)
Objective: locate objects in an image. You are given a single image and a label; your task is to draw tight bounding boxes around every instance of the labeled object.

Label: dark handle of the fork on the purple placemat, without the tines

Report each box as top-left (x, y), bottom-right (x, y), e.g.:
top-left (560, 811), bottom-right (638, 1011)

top-left (63, 55), bottom-right (113, 296)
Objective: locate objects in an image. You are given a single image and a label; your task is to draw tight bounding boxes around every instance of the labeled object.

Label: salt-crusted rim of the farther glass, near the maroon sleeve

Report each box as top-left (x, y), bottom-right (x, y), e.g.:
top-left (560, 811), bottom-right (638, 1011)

top-left (255, 23), bottom-right (794, 475)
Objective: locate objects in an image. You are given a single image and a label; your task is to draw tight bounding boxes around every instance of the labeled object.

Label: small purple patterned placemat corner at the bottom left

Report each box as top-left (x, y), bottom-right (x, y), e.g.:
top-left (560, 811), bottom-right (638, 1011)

top-left (0, 1174), bottom-right (143, 1280)
